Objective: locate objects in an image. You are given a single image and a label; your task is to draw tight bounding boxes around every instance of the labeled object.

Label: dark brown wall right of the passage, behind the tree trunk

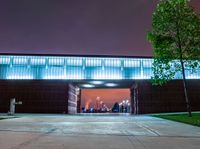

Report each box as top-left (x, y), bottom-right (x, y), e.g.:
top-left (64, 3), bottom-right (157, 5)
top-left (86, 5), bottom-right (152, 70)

top-left (131, 80), bottom-right (200, 114)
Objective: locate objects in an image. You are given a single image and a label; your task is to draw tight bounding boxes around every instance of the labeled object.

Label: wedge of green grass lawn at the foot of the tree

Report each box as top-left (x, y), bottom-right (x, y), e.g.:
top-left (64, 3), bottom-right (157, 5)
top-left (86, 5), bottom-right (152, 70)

top-left (153, 113), bottom-right (200, 127)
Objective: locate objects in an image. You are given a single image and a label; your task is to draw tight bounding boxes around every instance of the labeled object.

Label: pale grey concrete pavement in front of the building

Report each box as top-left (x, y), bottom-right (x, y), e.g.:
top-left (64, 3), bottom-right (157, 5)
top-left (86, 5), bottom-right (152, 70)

top-left (0, 115), bottom-right (200, 149)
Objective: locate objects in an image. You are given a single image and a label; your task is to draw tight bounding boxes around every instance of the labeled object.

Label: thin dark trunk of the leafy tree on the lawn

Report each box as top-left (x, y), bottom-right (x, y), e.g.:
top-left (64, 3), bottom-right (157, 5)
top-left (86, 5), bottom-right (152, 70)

top-left (180, 59), bottom-right (192, 117)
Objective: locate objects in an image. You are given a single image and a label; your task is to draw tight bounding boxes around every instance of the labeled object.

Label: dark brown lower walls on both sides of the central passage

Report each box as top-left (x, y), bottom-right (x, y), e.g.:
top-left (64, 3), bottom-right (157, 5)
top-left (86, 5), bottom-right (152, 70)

top-left (0, 80), bottom-right (200, 114)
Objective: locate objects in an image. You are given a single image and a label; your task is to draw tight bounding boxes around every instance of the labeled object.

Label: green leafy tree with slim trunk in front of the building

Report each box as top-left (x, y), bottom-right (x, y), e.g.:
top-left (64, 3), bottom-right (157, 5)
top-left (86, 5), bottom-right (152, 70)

top-left (147, 0), bottom-right (200, 116)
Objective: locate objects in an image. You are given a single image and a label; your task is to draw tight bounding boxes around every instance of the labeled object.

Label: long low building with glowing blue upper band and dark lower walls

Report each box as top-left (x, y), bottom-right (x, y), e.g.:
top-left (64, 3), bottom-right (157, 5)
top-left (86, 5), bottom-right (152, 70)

top-left (0, 54), bottom-right (200, 114)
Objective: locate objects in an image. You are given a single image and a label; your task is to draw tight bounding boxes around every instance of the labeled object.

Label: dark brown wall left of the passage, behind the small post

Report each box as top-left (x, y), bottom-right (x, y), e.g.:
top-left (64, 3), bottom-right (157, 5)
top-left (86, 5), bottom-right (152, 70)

top-left (0, 80), bottom-right (68, 113)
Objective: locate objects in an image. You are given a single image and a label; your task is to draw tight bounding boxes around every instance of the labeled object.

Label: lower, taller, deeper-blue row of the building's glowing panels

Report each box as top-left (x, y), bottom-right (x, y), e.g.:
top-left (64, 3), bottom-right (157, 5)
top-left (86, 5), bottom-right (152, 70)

top-left (0, 68), bottom-right (200, 79)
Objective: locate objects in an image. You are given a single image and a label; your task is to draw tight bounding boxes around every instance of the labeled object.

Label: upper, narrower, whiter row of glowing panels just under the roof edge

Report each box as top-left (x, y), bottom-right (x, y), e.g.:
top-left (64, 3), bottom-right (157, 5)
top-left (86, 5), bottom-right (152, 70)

top-left (0, 57), bottom-right (152, 67)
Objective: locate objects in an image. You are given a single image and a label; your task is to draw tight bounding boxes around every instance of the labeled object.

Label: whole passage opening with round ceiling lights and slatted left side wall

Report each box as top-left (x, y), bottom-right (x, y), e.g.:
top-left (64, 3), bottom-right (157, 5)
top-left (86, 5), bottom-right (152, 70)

top-left (68, 80), bottom-right (135, 114)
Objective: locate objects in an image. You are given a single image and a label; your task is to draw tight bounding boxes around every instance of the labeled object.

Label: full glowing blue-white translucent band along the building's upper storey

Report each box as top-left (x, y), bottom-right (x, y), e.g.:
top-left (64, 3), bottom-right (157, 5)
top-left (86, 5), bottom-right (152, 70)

top-left (0, 55), bottom-right (200, 80)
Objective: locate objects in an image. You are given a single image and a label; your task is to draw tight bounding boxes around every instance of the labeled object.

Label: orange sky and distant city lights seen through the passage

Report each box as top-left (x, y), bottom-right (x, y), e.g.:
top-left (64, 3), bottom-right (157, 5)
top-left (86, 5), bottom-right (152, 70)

top-left (80, 88), bottom-right (131, 113)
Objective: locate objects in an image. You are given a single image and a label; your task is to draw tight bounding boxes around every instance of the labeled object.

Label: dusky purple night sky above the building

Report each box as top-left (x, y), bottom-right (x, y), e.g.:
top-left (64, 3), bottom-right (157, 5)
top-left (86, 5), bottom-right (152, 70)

top-left (0, 0), bottom-right (200, 56)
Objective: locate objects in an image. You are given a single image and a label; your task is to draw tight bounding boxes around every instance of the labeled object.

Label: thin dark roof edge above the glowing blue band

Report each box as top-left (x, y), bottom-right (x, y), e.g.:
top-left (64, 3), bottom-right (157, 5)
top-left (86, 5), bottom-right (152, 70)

top-left (0, 53), bottom-right (153, 58)
